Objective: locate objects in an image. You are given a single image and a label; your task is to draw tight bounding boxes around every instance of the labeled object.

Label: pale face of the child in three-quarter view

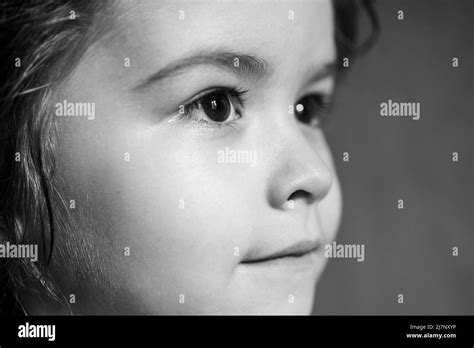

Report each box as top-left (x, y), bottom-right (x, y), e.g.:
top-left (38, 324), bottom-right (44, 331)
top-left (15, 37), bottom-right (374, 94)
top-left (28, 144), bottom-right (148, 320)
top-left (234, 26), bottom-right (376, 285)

top-left (51, 0), bottom-right (341, 314)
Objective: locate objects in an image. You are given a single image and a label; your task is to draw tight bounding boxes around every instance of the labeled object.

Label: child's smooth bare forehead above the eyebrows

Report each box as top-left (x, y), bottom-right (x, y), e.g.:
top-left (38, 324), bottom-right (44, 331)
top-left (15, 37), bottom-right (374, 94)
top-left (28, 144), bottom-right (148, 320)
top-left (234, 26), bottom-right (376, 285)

top-left (110, 0), bottom-right (335, 82)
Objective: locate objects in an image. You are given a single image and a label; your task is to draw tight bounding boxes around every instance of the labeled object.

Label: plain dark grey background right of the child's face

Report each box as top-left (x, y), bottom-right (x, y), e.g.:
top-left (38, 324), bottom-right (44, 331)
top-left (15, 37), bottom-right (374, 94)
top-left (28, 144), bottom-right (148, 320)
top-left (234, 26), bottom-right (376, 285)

top-left (314, 0), bottom-right (474, 315)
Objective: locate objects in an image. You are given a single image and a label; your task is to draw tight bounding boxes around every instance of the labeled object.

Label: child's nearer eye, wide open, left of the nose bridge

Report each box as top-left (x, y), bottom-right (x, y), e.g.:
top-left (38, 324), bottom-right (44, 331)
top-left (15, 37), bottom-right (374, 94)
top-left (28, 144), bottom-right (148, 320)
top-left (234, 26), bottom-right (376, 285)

top-left (180, 88), bottom-right (247, 125)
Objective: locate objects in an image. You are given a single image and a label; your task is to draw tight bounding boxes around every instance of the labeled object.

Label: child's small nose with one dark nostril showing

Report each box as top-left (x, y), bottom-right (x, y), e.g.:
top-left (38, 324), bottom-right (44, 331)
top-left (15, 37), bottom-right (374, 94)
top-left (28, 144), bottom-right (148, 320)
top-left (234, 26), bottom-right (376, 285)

top-left (267, 131), bottom-right (333, 210)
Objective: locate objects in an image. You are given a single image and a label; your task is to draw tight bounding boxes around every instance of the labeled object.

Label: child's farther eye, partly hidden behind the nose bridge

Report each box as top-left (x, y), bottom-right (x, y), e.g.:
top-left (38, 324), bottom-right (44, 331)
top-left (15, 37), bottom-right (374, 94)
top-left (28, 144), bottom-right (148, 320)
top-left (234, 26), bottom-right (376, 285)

top-left (294, 94), bottom-right (332, 127)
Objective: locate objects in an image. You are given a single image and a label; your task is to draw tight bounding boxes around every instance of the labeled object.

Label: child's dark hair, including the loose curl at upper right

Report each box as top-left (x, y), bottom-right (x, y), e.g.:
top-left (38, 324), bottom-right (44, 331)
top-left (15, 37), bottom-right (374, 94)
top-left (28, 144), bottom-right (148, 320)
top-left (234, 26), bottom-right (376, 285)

top-left (0, 0), bottom-right (378, 315)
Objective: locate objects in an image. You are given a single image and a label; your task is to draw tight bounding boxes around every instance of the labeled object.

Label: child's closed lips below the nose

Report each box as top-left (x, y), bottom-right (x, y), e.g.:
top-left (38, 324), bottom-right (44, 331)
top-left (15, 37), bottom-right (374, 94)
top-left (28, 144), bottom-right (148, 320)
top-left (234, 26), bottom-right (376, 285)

top-left (241, 240), bottom-right (321, 265)
